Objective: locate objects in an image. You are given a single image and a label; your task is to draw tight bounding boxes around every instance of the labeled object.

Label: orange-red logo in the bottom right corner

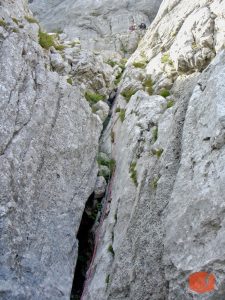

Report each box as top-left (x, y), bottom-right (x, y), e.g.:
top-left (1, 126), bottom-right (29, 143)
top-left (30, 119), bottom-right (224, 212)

top-left (189, 272), bottom-right (216, 294)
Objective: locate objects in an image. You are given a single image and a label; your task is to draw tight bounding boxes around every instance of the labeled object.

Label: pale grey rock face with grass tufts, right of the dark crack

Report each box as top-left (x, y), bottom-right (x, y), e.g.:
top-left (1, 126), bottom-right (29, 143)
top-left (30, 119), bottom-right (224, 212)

top-left (84, 0), bottom-right (225, 300)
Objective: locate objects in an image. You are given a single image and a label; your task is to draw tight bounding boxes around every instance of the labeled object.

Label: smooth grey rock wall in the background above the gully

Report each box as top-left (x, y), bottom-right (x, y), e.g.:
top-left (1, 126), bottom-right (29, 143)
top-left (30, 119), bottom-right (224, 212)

top-left (29, 0), bottom-right (161, 53)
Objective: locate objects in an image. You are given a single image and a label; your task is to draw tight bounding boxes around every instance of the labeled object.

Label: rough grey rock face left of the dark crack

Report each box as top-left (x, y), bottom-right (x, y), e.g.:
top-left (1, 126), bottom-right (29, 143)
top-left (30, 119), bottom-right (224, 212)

top-left (0, 0), bottom-right (102, 300)
